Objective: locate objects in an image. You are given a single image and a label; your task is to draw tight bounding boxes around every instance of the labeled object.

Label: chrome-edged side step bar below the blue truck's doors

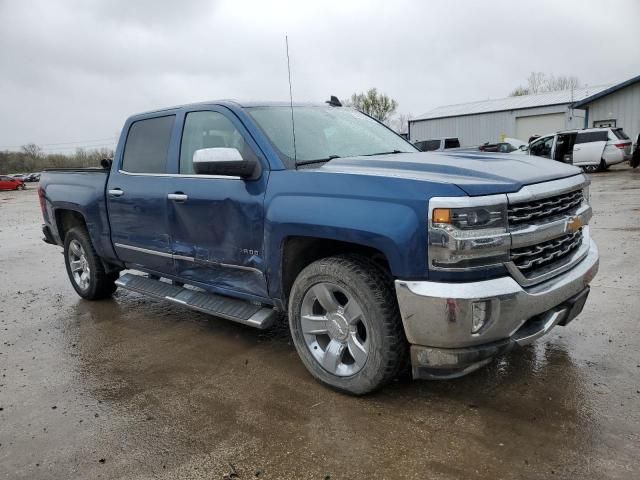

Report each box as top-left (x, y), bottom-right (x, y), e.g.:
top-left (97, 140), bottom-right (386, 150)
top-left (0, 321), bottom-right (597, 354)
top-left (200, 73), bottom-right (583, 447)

top-left (116, 273), bottom-right (276, 330)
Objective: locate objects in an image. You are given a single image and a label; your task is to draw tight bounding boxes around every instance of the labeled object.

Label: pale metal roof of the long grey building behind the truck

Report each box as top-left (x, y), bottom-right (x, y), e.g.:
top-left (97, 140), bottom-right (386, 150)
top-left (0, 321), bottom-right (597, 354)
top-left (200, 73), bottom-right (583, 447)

top-left (411, 84), bottom-right (613, 122)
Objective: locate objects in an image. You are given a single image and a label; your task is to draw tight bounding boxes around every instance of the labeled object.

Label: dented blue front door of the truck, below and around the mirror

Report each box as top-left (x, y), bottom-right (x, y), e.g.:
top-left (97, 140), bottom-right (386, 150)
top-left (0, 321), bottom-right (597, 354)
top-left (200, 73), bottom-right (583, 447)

top-left (168, 107), bottom-right (269, 297)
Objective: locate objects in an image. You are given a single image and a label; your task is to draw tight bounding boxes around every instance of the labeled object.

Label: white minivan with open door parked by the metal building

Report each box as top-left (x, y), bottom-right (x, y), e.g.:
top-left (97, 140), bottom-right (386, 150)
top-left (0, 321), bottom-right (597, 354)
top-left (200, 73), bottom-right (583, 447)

top-left (528, 128), bottom-right (632, 173)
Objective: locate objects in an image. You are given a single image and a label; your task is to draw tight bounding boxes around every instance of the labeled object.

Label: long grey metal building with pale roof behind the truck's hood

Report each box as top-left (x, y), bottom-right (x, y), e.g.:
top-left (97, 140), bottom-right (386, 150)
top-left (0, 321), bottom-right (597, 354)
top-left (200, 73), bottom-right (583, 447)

top-left (409, 85), bottom-right (612, 146)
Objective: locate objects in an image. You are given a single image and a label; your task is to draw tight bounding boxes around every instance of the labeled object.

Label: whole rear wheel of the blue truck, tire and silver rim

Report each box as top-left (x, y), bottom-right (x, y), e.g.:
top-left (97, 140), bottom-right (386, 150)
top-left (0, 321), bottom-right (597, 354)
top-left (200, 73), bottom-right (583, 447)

top-left (64, 227), bottom-right (119, 300)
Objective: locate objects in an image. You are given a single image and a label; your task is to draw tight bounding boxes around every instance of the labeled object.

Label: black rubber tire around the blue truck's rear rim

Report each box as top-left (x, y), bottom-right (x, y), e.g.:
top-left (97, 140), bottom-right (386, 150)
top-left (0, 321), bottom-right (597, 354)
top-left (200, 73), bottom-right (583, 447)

top-left (64, 227), bottom-right (120, 300)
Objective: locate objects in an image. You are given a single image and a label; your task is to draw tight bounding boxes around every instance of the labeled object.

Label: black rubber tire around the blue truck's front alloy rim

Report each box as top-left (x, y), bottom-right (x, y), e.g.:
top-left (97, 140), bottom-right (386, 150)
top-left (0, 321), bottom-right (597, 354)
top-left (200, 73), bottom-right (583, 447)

top-left (289, 255), bottom-right (408, 395)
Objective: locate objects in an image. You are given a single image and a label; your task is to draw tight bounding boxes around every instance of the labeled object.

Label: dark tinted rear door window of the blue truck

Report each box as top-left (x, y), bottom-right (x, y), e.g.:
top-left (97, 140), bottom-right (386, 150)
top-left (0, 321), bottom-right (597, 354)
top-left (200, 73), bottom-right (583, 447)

top-left (122, 115), bottom-right (175, 173)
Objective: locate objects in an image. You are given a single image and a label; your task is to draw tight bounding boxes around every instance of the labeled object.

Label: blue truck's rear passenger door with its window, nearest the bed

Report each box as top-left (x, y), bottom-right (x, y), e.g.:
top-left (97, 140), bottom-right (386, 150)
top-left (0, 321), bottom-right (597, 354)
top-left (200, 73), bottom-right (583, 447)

top-left (107, 115), bottom-right (175, 274)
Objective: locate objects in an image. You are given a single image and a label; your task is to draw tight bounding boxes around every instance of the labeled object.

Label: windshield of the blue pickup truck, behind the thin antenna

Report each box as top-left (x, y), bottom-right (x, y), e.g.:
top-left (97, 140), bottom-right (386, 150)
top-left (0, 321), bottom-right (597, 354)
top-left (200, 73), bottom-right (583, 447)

top-left (246, 106), bottom-right (418, 166)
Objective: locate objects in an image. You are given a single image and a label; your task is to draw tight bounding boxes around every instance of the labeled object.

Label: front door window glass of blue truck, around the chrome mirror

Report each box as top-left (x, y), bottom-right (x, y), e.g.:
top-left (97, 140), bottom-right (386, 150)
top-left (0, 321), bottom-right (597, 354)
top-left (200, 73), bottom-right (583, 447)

top-left (180, 111), bottom-right (255, 175)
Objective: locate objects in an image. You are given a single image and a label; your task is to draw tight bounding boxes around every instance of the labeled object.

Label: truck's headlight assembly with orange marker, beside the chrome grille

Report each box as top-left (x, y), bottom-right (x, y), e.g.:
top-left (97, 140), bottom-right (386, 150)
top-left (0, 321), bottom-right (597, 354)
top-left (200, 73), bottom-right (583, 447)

top-left (428, 195), bottom-right (510, 270)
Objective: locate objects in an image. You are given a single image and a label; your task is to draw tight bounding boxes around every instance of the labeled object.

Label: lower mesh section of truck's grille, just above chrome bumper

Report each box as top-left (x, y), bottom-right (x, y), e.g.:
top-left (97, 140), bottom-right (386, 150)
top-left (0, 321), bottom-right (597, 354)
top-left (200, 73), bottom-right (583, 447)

top-left (511, 228), bottom-right (582, 277)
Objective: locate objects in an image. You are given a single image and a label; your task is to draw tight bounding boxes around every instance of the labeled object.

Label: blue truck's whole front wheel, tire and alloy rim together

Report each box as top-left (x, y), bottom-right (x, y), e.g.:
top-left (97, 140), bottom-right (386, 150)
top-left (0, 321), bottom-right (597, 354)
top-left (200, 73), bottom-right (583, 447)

top-left (289, 255), bottom-right (407, 395)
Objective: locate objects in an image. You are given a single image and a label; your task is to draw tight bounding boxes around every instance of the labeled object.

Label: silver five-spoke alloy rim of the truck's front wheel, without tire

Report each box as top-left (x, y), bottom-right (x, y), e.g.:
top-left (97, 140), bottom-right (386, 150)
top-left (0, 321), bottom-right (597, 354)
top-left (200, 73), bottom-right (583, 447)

top-left (300, 282), bottom-right (369, 377)
